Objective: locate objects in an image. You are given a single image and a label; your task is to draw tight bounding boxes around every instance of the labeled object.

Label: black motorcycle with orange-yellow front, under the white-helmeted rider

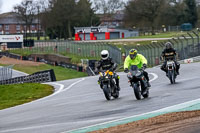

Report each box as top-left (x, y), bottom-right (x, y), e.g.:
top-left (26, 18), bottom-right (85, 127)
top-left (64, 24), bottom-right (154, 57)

top-left (99, 70), bottom-right (119, 100)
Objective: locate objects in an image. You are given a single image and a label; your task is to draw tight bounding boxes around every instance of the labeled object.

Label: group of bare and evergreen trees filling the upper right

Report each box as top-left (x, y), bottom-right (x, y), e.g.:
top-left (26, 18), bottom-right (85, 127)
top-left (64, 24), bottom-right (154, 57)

top-left (124, 0), bottom-right (200, 34)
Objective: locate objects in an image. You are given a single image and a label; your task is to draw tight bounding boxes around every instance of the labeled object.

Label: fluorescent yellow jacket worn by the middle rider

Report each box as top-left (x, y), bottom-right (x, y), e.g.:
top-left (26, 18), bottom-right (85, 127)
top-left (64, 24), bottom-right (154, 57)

top-left (124, 54), bottom-right (147, 69)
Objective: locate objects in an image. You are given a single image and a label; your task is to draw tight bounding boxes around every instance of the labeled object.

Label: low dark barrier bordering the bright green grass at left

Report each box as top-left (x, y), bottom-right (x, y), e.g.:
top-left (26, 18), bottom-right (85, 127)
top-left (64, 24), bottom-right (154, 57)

top-left (0, 69), bottom-right (56, 85)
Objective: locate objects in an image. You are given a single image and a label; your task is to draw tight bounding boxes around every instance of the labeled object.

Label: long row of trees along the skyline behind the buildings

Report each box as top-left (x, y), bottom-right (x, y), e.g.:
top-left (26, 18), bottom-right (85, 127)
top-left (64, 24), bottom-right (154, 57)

top-left (14, 0), bottom-right (200, 39)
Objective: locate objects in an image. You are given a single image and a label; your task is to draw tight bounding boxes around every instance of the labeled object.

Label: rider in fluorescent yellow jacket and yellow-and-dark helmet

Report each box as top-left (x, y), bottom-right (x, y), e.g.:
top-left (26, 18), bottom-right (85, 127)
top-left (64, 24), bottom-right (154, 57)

top-left (124, 49), bottom-right (151, 87)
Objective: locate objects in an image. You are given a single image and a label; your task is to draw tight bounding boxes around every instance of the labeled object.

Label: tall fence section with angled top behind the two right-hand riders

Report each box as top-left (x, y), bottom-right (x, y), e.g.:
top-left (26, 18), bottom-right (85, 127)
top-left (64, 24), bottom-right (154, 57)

top-left (125, 31), bottom-right (200, 66)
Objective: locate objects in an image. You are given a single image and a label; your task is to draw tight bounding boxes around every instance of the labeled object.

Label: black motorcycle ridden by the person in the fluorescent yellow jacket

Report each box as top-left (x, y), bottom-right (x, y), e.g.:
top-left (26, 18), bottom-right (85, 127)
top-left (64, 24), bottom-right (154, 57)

top-left (127, 65), bottom-right (149, 100)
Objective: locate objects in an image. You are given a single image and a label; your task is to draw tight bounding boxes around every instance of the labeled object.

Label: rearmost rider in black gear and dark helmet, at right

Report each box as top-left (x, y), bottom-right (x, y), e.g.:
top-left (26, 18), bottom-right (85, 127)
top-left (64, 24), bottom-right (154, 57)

top-left (161, 42), bottom-right (180, 75)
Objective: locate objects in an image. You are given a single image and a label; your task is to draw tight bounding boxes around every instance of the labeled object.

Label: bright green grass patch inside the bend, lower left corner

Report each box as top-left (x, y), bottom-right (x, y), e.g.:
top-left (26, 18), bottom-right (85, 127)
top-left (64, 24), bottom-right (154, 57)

top-left (0, 83), bottom-right (54, 109)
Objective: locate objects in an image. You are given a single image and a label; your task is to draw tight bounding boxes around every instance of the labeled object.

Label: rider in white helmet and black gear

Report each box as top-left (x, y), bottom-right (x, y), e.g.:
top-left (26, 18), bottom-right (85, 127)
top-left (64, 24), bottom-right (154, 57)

top-left (97, 50), bottom-right (120, 90)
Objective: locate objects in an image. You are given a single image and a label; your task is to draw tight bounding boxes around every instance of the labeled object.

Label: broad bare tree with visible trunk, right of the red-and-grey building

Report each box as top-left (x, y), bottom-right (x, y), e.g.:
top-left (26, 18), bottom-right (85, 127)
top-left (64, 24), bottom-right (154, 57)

top-left (124, 0), bottom-right (166, 35)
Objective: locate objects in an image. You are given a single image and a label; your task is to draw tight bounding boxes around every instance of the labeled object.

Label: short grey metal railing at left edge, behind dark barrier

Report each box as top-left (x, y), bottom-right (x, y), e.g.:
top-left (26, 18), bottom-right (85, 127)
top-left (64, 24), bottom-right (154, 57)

top-left (0, 65), bottom-right (13, 81)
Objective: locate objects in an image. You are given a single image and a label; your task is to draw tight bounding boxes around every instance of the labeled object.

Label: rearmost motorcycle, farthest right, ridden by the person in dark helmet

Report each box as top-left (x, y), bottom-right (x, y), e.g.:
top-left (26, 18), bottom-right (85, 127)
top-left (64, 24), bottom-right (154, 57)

top-left (166, 60), bottom-right (177, 84)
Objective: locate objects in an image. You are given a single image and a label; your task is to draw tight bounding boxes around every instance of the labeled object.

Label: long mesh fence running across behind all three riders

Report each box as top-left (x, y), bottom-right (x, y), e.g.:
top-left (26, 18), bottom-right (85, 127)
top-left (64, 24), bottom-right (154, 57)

top-left (6, 31), bottom-right (200, 66)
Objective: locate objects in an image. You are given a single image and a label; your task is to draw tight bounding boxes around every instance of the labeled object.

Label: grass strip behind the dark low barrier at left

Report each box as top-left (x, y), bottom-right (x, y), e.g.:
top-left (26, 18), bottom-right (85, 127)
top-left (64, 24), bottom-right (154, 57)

top-left (9, 64), bottom-right (87, 81)
